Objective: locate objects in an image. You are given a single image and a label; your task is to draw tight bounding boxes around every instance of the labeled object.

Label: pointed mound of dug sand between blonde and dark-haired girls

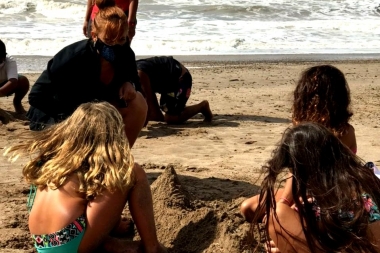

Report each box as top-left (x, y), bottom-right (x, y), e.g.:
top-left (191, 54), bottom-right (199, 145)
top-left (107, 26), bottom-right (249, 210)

top-left (148, 165), bottom-right (255, 252)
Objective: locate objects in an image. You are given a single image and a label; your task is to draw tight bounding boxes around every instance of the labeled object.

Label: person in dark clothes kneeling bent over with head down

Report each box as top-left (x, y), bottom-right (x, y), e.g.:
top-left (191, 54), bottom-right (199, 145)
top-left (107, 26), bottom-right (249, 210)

top-left (136, 56), bottom-right (213, 124)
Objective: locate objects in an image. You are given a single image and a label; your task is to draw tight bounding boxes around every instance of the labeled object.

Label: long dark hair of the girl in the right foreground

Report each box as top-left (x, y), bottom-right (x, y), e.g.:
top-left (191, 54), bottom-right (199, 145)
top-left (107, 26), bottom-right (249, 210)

top-left (251, 122), bottom-right (380, 253)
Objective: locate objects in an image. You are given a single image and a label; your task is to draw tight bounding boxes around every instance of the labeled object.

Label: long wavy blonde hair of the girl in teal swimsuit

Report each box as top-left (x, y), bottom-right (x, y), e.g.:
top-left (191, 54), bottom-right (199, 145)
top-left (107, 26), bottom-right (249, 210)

top-left (5, 102), bottom-right (134, 200)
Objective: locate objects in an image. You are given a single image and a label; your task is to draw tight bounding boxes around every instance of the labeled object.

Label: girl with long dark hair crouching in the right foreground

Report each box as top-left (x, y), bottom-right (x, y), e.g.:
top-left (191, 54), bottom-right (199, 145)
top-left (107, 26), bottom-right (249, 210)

top-left (252, 123), bottom-right (380, 253)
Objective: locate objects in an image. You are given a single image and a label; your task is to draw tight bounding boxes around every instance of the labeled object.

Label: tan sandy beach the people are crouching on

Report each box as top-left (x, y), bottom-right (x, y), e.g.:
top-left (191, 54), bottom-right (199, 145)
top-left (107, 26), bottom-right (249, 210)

top-left (0, 60), bottom-right (380, 253)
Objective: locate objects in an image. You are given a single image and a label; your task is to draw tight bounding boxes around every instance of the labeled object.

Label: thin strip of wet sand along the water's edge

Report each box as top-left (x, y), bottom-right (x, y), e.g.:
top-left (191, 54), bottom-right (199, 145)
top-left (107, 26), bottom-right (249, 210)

top-left (12, 53), bottom-right (380, 74)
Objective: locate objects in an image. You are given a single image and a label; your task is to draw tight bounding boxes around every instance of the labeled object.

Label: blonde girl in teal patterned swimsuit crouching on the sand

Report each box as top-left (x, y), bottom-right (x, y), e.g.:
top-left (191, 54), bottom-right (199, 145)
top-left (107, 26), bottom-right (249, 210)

top-left (6, 102), bottom-right (165, 253)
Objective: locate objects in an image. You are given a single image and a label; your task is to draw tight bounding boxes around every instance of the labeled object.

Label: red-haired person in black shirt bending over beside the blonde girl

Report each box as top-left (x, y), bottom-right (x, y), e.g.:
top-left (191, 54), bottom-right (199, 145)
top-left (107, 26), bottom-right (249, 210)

top-left (27, 0), bottom-right (147, 147)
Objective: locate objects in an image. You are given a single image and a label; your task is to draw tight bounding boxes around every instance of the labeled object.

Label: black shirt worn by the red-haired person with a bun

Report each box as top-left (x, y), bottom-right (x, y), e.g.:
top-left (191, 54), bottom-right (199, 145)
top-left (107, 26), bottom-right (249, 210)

top-left (27, 39), bottom-right (141, 122)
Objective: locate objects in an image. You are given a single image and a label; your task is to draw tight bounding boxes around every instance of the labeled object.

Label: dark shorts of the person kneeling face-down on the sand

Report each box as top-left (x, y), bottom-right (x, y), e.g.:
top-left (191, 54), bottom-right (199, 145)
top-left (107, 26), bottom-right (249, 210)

top-left (160, 72), bottom-right (193, 115)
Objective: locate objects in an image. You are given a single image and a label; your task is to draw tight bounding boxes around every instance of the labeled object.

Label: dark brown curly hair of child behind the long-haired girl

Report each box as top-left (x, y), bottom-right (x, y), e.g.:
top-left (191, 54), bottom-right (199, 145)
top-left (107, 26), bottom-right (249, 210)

top-left (293, 65), bottom-right (353, 136)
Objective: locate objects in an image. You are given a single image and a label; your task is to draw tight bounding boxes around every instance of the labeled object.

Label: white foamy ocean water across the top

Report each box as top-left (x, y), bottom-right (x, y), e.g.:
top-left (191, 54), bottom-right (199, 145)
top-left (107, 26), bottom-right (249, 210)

top-left (0, 0), bottom-right (380, 71)
